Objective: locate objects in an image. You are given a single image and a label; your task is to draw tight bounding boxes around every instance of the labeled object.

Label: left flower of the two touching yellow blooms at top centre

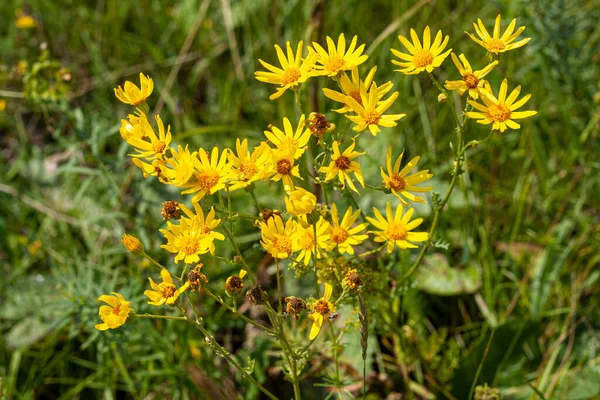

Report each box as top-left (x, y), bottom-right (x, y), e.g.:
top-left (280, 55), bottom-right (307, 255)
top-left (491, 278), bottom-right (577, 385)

top-left (254, 41), bottom-right (318, 100)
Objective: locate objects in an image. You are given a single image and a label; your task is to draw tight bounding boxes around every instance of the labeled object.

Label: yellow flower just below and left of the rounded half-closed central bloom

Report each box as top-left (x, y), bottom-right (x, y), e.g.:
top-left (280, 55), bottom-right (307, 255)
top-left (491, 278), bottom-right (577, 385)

top-left (260, 215), bottom-right (298, 259)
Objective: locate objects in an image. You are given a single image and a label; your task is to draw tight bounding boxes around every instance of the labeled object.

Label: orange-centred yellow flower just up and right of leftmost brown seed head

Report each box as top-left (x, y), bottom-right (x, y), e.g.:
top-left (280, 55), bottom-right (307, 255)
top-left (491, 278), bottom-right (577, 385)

top-left (181, 147), bottom-right (231, 201)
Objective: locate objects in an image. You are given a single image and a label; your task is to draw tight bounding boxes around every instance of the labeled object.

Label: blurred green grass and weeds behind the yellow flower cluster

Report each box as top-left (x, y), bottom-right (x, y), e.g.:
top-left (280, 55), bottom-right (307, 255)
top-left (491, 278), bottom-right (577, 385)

top-left (0, 0), bottom-right (600, 399)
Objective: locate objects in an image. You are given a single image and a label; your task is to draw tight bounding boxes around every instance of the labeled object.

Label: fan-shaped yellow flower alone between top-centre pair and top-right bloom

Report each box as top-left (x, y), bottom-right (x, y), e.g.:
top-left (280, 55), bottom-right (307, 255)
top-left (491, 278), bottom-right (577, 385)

top-left (390, 26), bottom-right (452, 75)
